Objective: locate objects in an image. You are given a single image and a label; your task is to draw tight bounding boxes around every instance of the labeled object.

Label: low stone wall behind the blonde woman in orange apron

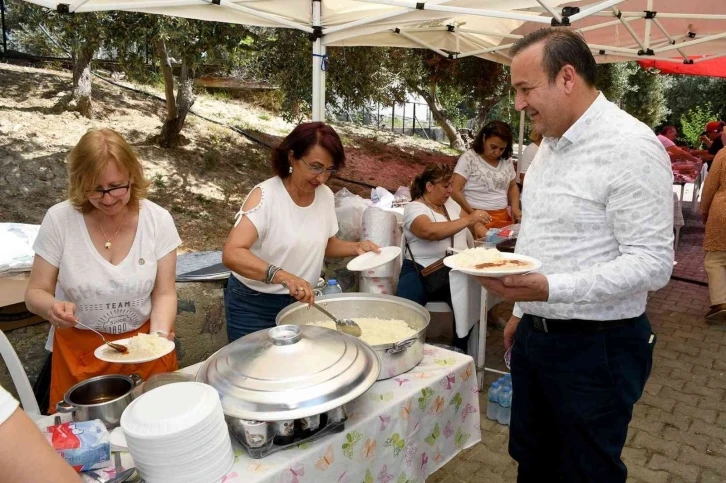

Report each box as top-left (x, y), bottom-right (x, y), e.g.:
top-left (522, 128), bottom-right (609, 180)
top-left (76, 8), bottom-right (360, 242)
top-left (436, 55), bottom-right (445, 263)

top-left (0, 281), bottom-right (227, 404)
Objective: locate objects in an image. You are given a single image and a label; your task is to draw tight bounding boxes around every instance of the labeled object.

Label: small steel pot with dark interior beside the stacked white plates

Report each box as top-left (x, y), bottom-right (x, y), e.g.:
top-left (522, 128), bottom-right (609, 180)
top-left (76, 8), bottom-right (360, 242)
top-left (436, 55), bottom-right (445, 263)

top-left (56, 374), bottom-right (143, 429)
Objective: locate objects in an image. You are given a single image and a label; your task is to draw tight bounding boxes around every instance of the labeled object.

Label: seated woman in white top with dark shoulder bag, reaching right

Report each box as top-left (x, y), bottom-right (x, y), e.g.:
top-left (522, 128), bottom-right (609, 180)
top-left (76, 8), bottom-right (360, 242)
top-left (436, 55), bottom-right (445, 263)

top-left (396, 164), bottom-right (491, 352)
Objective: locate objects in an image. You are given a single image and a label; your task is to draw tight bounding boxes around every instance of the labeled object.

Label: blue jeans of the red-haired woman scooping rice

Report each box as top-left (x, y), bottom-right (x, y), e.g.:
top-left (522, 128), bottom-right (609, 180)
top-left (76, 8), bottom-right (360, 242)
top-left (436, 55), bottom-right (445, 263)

top-left (224, 275), bottom-right (295, 342)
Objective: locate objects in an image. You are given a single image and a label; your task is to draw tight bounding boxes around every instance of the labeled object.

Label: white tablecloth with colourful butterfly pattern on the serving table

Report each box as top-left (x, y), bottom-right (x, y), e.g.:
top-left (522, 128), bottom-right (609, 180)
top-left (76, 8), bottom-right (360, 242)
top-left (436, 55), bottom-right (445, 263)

top-left (223, 345), bottom-right (481, 483)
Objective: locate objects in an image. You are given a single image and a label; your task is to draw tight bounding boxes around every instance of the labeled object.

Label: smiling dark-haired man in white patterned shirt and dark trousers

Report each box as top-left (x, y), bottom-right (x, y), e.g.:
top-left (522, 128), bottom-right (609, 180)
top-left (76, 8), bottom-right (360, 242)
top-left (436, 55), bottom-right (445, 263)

top-left (480, 28), bottom-right (673, 483)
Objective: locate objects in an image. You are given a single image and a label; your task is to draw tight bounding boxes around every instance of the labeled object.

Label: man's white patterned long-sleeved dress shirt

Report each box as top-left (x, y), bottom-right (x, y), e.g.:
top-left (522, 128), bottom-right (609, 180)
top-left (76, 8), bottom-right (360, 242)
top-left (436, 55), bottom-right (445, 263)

top-left (514, 94), bottom-right (673, 320)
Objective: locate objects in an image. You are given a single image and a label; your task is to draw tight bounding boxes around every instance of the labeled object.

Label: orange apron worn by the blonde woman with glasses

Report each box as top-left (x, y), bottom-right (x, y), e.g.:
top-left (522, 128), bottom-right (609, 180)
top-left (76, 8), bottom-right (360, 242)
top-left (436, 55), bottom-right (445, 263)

top-left (48, 320), bottom-right (178, 413)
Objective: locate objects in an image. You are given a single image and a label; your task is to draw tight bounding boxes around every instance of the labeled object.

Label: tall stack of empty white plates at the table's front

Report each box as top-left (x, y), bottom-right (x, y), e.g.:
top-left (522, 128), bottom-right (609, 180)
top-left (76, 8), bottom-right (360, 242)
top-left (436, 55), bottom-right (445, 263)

top-left (121, 382), bottom-right (234, 483)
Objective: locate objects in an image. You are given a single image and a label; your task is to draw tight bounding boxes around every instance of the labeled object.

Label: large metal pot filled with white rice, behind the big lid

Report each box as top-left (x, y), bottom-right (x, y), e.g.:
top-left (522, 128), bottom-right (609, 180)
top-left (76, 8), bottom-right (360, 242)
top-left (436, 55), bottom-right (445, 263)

top-left (275, 293), bottom-right (431, 380)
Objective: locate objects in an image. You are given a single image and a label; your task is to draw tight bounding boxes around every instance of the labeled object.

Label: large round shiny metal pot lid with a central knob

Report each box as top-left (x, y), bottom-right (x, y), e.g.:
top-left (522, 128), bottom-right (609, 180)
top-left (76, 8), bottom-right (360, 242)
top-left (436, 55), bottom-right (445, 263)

top-left (197, 325), bottom-right (380, 421)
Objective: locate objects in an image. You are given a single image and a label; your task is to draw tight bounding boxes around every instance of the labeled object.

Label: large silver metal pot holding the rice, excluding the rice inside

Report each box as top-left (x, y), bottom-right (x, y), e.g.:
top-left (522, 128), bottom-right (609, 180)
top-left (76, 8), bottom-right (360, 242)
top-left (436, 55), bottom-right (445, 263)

top-left (275, 293), bottom-right (431, 380)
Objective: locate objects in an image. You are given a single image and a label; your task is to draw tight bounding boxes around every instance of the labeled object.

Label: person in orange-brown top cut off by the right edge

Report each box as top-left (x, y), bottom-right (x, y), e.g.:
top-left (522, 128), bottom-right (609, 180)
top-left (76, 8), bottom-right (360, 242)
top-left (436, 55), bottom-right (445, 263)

top-left (701, 149), bottom-right (726, 320)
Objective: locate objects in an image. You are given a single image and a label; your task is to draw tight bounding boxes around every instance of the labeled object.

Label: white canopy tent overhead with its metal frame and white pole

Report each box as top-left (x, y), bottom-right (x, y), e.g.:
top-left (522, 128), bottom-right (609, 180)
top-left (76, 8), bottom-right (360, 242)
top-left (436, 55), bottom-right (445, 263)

top-left (19, 0), bottom-right (726, 120)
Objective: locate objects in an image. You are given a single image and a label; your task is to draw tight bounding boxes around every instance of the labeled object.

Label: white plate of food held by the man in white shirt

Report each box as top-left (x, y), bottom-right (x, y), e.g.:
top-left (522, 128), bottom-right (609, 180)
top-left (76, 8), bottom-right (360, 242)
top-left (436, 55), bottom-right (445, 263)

top-left (444, 247), bottom-right (542, 278)
